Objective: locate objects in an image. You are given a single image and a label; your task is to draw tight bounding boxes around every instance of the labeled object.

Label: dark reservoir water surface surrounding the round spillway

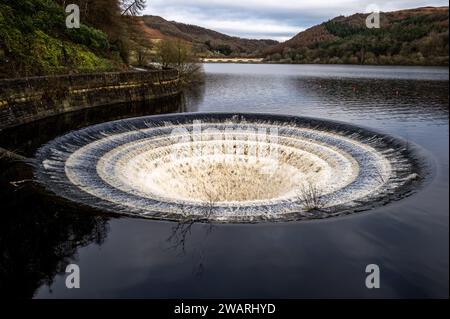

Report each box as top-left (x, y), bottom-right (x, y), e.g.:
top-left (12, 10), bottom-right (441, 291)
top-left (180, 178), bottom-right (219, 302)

top-left (0, 64), bottom-right (449, 298)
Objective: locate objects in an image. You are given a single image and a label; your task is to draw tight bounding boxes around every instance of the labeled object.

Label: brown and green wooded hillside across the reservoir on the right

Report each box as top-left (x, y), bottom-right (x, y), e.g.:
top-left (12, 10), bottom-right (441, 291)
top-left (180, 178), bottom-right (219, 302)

top-left (265, 7), bottom-right (449, 65)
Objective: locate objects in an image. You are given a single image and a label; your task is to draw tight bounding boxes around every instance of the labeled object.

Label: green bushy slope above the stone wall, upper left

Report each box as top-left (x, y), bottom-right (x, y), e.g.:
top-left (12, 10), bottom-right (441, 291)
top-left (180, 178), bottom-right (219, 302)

top-left (0, 0), bottom-right (123, 78)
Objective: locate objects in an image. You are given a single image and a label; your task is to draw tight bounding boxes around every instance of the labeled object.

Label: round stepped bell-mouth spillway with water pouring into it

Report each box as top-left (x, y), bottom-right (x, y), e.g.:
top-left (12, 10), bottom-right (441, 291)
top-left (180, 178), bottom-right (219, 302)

top-left (35, 113), bottom-right (423, 222)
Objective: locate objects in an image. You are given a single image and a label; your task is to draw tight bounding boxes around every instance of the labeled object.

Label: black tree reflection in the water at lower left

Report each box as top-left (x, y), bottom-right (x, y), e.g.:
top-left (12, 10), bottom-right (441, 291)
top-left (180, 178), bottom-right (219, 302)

top-left (0, 161), bottom-right (108, 298)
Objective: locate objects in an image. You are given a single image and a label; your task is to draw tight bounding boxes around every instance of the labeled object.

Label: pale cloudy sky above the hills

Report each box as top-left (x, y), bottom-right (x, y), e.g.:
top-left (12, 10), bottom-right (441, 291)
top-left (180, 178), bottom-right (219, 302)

top-left (144, 0), bottom-right (448, 41)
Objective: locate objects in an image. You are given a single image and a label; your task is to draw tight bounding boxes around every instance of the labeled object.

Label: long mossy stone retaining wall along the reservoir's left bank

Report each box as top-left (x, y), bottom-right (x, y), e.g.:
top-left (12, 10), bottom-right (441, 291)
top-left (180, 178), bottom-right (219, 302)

top-left (0, 70), bottom-right (181, 131)
